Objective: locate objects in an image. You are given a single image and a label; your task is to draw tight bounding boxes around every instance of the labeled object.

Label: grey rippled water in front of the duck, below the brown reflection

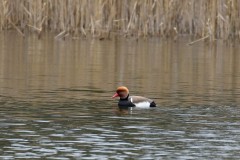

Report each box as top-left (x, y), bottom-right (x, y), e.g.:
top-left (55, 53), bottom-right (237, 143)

top-left (0, 102), bottom-right (240, 159)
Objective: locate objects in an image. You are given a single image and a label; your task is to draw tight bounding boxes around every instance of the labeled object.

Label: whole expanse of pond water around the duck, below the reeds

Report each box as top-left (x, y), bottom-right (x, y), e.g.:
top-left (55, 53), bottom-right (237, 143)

top-left (0, 32), bottom-right (240, 160)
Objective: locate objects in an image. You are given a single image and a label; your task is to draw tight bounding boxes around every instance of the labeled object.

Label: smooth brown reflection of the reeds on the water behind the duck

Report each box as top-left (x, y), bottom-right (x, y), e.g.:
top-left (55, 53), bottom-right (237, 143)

top-left (0, 32), bottom-right (240, 105)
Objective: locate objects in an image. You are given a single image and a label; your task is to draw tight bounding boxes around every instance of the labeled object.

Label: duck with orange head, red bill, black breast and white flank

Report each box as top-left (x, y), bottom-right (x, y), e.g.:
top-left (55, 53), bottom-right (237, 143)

top-left (112, 86), bottom-right (157, 108)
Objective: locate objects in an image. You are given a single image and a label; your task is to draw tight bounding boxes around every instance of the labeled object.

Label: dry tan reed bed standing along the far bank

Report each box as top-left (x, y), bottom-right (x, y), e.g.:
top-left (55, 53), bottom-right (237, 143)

top-left (0, 0), bottom-right (240, 40)
